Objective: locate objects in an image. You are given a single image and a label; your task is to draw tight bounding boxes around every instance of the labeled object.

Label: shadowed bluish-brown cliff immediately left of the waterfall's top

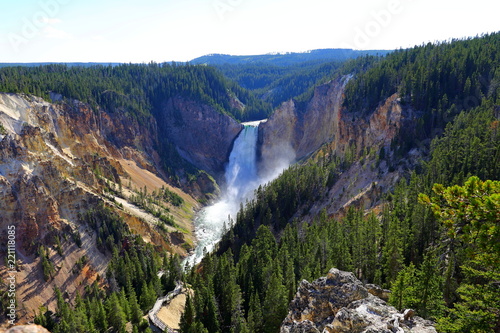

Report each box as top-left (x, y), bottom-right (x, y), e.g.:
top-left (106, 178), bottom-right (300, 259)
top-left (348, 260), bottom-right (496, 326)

top-left (158, 97), bottom-right (243, 177)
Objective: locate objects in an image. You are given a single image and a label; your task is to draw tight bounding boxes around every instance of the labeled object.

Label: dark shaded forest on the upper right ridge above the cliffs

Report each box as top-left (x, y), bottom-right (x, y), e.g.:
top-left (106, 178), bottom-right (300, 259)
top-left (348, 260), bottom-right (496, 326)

top-left (344, 33), bottom-right (500, 141)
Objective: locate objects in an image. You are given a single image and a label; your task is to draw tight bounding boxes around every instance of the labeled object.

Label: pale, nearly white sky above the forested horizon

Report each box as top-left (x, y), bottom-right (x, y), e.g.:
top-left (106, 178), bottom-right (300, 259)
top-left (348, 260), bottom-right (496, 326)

top-left (0, 0), bottom-right (500, 63)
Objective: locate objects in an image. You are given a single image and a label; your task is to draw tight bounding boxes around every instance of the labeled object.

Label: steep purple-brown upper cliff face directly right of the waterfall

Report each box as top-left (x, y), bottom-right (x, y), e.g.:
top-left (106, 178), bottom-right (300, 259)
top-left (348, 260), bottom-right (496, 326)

top-left (259, 76), bottom-right (402, 164)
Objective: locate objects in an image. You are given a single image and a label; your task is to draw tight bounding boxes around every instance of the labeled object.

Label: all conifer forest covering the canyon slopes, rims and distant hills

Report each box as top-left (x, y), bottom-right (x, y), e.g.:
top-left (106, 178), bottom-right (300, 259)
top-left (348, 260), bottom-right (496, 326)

top-left (0, 34), bottom-right (500, 333)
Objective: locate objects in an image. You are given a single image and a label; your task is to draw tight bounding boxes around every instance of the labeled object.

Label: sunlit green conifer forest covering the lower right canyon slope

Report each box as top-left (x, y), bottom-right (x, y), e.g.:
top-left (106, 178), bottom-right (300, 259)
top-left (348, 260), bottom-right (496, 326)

top-left (185, 103), bottom-right (500, 332)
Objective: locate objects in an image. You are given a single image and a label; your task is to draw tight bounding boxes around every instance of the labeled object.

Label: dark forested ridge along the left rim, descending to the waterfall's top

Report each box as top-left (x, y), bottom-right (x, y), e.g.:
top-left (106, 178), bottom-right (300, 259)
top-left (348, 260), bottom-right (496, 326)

top-left (0, 63), bottom-right (271, 121)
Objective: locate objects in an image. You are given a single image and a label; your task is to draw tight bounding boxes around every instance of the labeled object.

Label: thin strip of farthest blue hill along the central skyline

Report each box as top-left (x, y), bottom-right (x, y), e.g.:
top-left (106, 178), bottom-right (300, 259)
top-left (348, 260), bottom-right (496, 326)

top-left (191, 49), bottom-right (391, 66)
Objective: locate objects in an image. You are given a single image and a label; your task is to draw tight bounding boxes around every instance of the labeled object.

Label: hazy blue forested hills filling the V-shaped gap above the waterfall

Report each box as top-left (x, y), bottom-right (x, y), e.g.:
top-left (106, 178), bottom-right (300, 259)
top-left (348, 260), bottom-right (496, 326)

top-left (191, 49), bottom-right (392, 107)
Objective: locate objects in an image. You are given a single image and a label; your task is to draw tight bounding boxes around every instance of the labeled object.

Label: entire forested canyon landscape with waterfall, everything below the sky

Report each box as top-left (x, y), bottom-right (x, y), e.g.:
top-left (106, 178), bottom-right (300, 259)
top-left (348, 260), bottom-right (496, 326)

top-left (0, 33), bottom-right (500, 333)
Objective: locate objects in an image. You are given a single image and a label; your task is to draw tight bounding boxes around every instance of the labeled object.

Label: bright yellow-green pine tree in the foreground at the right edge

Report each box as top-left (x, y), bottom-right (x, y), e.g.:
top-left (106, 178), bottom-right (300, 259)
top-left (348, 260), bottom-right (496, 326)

top-left (419, 177), bottom-right (500, 332)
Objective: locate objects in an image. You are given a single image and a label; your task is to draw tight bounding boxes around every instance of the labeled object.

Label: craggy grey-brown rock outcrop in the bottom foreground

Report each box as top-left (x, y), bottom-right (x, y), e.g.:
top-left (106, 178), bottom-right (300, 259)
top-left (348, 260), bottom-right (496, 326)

top-left (280, 268), bottom-right (436, 333)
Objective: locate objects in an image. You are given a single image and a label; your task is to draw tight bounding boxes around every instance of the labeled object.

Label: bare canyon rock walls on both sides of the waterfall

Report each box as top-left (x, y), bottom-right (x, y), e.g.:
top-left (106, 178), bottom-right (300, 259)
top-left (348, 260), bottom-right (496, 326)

top-left (0, 76), bottom-right (418, 321)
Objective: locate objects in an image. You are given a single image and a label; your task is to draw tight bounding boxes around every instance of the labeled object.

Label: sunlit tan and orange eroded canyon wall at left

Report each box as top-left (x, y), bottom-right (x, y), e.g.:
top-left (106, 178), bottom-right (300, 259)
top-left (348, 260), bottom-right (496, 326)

top-left (0, 94), bottom-right (198, 323)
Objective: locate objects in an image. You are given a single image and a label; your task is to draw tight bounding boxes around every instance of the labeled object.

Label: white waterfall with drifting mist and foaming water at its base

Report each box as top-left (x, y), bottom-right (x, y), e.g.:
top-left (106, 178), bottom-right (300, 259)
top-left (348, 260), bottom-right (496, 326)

top-left (184, 121), bottom-right (295, 266)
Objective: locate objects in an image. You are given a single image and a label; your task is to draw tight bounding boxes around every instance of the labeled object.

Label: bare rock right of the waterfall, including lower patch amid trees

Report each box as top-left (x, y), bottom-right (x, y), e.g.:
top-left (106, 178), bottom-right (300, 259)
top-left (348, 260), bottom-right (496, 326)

top-left (259, 76), bottom-right (421, 216)
